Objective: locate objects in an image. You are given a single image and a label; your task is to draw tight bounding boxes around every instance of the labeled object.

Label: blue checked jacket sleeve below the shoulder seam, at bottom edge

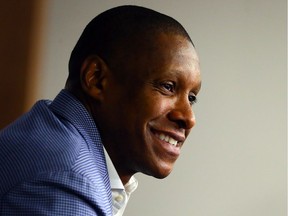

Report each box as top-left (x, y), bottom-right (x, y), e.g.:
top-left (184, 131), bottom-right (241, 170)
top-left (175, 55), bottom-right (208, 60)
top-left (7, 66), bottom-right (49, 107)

top-left (0, 170), bottom-right (111, 215)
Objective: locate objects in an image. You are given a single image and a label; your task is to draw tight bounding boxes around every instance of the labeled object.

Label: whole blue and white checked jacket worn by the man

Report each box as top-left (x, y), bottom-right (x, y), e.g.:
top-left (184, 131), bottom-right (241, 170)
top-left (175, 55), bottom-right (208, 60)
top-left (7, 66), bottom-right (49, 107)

top-left (0, 90), bottom-right (112, 216)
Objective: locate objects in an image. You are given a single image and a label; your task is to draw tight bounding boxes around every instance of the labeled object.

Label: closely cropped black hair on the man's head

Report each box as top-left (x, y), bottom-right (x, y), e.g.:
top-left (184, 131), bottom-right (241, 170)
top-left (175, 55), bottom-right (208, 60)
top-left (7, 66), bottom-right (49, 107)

top-left (68, 5), bottom-right (194, 81)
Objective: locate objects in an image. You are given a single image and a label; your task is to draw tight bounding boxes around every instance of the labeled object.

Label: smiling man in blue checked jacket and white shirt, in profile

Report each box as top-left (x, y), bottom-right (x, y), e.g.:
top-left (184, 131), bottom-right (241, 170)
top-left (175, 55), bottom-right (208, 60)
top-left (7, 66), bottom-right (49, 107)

top-left (0, 6), bottom-right (201, 215)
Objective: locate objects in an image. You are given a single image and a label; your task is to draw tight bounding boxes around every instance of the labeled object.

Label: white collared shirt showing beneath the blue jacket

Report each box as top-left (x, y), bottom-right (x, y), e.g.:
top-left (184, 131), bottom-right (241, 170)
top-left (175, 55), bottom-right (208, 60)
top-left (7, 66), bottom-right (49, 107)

top-left (104, 148), bottom-right (138, 216)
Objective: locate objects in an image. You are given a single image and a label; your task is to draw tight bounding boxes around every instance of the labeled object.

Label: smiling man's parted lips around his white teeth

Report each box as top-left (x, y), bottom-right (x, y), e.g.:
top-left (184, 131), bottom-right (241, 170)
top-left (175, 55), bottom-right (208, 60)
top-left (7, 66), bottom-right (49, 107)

top-left (151, 128), bottom-right (185, 158)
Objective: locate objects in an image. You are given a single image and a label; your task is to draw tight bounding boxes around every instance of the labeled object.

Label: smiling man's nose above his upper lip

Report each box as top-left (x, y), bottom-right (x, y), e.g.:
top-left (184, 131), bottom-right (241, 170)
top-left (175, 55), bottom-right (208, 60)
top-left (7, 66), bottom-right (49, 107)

top-left (168, 99), bottom-right (196, 129)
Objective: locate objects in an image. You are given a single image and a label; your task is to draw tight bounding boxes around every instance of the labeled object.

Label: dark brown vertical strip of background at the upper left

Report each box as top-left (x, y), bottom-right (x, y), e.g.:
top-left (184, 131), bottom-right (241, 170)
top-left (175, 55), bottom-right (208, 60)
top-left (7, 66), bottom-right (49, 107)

top-left (0, 0), bottom-right (43, 129)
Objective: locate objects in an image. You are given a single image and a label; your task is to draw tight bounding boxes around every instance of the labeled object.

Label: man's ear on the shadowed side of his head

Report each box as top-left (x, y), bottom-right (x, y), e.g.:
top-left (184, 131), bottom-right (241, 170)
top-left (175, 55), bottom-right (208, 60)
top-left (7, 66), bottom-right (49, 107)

top-left (80, 56), bottom-right (109, 101)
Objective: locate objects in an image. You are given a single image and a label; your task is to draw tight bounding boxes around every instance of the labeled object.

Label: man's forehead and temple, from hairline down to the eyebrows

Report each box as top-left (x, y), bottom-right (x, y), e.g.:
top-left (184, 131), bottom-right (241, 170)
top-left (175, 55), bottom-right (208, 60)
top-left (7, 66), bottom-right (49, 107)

top-left (112, 33), bottom-right (201, 91)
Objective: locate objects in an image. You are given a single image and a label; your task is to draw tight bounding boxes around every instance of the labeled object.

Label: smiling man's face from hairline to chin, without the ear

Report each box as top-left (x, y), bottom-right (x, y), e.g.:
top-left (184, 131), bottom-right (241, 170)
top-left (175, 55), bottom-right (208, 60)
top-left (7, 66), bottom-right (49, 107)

top-left (98, 34), bottom-right (201, 178)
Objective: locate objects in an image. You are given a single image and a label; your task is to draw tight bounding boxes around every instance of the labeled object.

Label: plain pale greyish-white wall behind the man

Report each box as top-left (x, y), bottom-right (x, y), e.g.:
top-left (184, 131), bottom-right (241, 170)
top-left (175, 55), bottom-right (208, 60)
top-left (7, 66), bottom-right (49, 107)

top-left (38, 0), bottom-right (287, 216)
